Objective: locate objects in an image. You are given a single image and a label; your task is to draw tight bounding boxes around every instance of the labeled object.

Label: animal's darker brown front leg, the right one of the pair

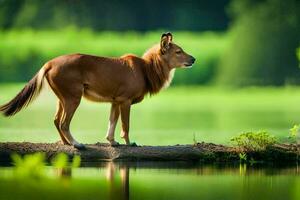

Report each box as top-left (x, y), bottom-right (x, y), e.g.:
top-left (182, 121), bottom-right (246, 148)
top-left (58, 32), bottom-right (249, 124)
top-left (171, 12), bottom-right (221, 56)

top-left (120, 101), bottom-right (131, 145)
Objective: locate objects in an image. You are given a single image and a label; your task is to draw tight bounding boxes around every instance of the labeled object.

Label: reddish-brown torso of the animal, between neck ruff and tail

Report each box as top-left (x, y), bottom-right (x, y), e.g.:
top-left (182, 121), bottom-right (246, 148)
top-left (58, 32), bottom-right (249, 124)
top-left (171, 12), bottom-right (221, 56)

top-left (47, 54), bottom-right (145, 102)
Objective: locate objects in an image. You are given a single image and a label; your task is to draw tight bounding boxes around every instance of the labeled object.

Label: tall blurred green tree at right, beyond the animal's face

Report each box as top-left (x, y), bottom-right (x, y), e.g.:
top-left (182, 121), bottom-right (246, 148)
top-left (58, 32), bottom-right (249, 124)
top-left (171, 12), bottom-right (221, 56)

top-left (218, 0), bottom-right (300, 86)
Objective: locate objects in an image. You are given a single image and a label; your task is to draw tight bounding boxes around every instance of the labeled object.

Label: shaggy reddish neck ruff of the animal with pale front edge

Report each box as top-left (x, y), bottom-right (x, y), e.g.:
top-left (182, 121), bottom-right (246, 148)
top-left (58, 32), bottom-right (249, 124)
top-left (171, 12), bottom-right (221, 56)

top-left (143, 45), bottom-right (173, 95)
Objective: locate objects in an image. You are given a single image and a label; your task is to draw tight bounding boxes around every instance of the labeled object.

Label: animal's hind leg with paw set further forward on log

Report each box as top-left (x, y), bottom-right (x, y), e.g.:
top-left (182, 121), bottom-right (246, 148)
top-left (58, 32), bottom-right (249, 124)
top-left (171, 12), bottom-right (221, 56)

top-left (60, 97), bottom-right (85, 149)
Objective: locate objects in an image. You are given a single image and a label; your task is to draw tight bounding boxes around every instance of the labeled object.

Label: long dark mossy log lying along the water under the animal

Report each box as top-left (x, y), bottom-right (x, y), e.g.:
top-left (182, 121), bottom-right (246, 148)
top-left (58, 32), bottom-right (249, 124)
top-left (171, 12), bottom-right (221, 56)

top-left (0, 142), bottom-right (299, 163)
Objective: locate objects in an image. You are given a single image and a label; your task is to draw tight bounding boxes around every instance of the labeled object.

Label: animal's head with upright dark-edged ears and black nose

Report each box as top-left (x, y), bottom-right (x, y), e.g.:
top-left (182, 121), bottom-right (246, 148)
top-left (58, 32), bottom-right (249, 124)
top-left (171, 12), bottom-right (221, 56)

top-left (160, 32), bottom-right (196, 68)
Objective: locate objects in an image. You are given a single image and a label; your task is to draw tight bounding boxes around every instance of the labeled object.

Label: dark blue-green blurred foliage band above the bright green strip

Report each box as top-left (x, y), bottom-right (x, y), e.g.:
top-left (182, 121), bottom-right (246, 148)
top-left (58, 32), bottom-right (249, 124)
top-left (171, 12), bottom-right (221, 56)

top-left (0, 0), bottom-right (229, 31)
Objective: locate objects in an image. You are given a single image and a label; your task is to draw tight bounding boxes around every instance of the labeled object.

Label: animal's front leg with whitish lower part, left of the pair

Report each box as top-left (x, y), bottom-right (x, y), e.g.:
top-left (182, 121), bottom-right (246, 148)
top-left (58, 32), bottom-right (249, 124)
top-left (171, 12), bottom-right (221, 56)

top-left (106, 103), bottom-right (120, 146)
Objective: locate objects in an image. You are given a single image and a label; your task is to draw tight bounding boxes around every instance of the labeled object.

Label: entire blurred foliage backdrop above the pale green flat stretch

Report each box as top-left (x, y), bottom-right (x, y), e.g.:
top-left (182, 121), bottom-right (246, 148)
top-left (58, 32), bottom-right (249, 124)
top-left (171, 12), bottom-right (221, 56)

top-left (0, 0), bottom-right (300, 87)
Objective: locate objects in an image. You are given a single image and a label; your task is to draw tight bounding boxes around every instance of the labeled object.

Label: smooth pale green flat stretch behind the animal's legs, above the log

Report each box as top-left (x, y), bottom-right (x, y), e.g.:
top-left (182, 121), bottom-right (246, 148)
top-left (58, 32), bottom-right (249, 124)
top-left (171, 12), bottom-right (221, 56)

top-left (0, 84), bottom-right (300, 145)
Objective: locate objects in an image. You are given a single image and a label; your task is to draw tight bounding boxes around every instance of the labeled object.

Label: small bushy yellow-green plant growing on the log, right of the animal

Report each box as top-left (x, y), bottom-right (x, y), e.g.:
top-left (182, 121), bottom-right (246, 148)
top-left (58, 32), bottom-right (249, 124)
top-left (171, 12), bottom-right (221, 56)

top-left (231, 131), bottom-right (276, 151)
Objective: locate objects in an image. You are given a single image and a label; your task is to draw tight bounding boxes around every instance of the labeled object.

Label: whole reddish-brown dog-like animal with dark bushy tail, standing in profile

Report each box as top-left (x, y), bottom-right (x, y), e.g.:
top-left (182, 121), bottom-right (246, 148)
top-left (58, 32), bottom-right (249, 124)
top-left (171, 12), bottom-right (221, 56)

top-left (0, 33), bottom-right (195, 149)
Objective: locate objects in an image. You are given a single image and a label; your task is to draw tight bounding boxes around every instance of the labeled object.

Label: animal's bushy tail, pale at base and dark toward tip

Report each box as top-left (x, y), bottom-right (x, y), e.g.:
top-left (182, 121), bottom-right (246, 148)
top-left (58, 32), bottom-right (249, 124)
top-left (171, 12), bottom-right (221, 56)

top-left (0, 68), bottom-right (45, 117)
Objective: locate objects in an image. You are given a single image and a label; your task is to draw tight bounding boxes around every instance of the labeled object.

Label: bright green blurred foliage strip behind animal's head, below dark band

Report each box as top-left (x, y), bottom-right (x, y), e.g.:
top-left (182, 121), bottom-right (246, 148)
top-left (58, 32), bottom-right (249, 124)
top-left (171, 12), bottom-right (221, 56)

top-left (0, 27), bottom-right (227, 84)
